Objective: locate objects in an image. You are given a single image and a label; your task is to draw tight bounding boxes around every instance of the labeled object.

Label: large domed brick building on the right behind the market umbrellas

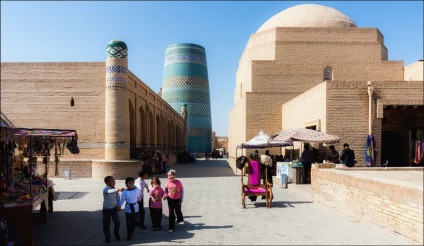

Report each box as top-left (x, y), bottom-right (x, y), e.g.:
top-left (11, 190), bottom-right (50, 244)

top-left (228, 4), bottom-right (424, 166)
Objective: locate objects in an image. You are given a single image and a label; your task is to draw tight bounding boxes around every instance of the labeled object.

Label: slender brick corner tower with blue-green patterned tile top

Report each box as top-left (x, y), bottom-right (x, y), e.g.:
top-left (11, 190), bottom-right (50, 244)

top-left (105, 40), bottom-right (130, 160)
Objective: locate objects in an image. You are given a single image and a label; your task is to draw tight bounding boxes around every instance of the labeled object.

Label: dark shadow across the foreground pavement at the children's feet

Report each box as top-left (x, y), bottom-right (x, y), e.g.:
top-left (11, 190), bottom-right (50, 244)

top-left (33, 209), bottom-right (233, 245)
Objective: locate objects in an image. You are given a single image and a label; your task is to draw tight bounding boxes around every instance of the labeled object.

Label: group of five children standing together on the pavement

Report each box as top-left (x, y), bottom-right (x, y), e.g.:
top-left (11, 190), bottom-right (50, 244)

top-left (102, 169), bottom-right (184, 243)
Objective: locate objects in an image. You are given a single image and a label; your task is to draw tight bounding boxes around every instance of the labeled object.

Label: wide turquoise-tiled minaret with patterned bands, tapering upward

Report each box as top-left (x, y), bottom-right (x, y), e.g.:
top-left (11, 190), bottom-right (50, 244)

top-left (162, 43), bottom-right (212, 153)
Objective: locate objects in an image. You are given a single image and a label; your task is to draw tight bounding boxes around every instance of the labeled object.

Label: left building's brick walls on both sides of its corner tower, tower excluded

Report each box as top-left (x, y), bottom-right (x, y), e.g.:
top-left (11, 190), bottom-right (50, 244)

top-left (1, 62), bottom-right (185, 160)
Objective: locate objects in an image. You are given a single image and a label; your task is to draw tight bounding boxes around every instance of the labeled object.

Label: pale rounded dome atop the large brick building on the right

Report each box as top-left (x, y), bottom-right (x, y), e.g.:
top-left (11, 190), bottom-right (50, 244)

top-left (256, 4), bottom-right (356, 32)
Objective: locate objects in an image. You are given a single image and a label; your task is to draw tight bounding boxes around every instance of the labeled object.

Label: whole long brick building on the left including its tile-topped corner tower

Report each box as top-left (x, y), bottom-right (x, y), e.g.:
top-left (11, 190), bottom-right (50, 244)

top-left (1, 40), bottom-right (187, 179)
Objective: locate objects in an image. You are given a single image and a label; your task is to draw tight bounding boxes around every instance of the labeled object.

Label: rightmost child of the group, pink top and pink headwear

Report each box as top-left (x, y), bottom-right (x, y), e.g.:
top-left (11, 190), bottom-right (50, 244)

top-left (163, 169), bottom-right (184, 233)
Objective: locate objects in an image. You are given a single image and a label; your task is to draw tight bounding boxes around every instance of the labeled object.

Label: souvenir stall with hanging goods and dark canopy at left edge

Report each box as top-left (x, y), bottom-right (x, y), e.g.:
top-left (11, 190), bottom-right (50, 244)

top-left (0, 126), bottom-right (79, 245)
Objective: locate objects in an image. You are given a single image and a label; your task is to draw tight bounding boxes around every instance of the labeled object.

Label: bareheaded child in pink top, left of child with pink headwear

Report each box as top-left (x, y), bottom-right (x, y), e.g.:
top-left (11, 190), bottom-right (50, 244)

top-left (149, 175), bottom-right (165, 231)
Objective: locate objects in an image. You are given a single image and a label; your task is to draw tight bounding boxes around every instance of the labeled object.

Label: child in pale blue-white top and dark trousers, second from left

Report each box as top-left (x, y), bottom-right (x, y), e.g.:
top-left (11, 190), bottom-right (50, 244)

top-left (118, 177), bottom-right (141, 241)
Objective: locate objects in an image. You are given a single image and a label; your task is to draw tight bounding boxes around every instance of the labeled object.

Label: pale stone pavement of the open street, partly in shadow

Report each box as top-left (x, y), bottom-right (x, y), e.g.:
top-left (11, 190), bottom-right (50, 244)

top-left (33, 159), bottom-right (418, 245)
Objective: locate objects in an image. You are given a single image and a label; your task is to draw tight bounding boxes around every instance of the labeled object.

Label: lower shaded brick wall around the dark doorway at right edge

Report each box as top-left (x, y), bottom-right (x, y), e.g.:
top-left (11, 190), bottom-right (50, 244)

top-left (326, 81), bottom-right (424, 166)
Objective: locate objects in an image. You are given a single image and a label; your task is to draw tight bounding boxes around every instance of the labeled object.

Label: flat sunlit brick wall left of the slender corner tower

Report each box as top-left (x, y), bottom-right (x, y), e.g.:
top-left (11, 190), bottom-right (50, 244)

top-left (1, 62), bottom-right (105, 158)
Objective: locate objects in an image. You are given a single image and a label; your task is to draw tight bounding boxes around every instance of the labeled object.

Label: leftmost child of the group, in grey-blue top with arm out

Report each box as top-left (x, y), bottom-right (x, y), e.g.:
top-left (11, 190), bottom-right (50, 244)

top-left (102, 176), bottom-right (124, 243)
